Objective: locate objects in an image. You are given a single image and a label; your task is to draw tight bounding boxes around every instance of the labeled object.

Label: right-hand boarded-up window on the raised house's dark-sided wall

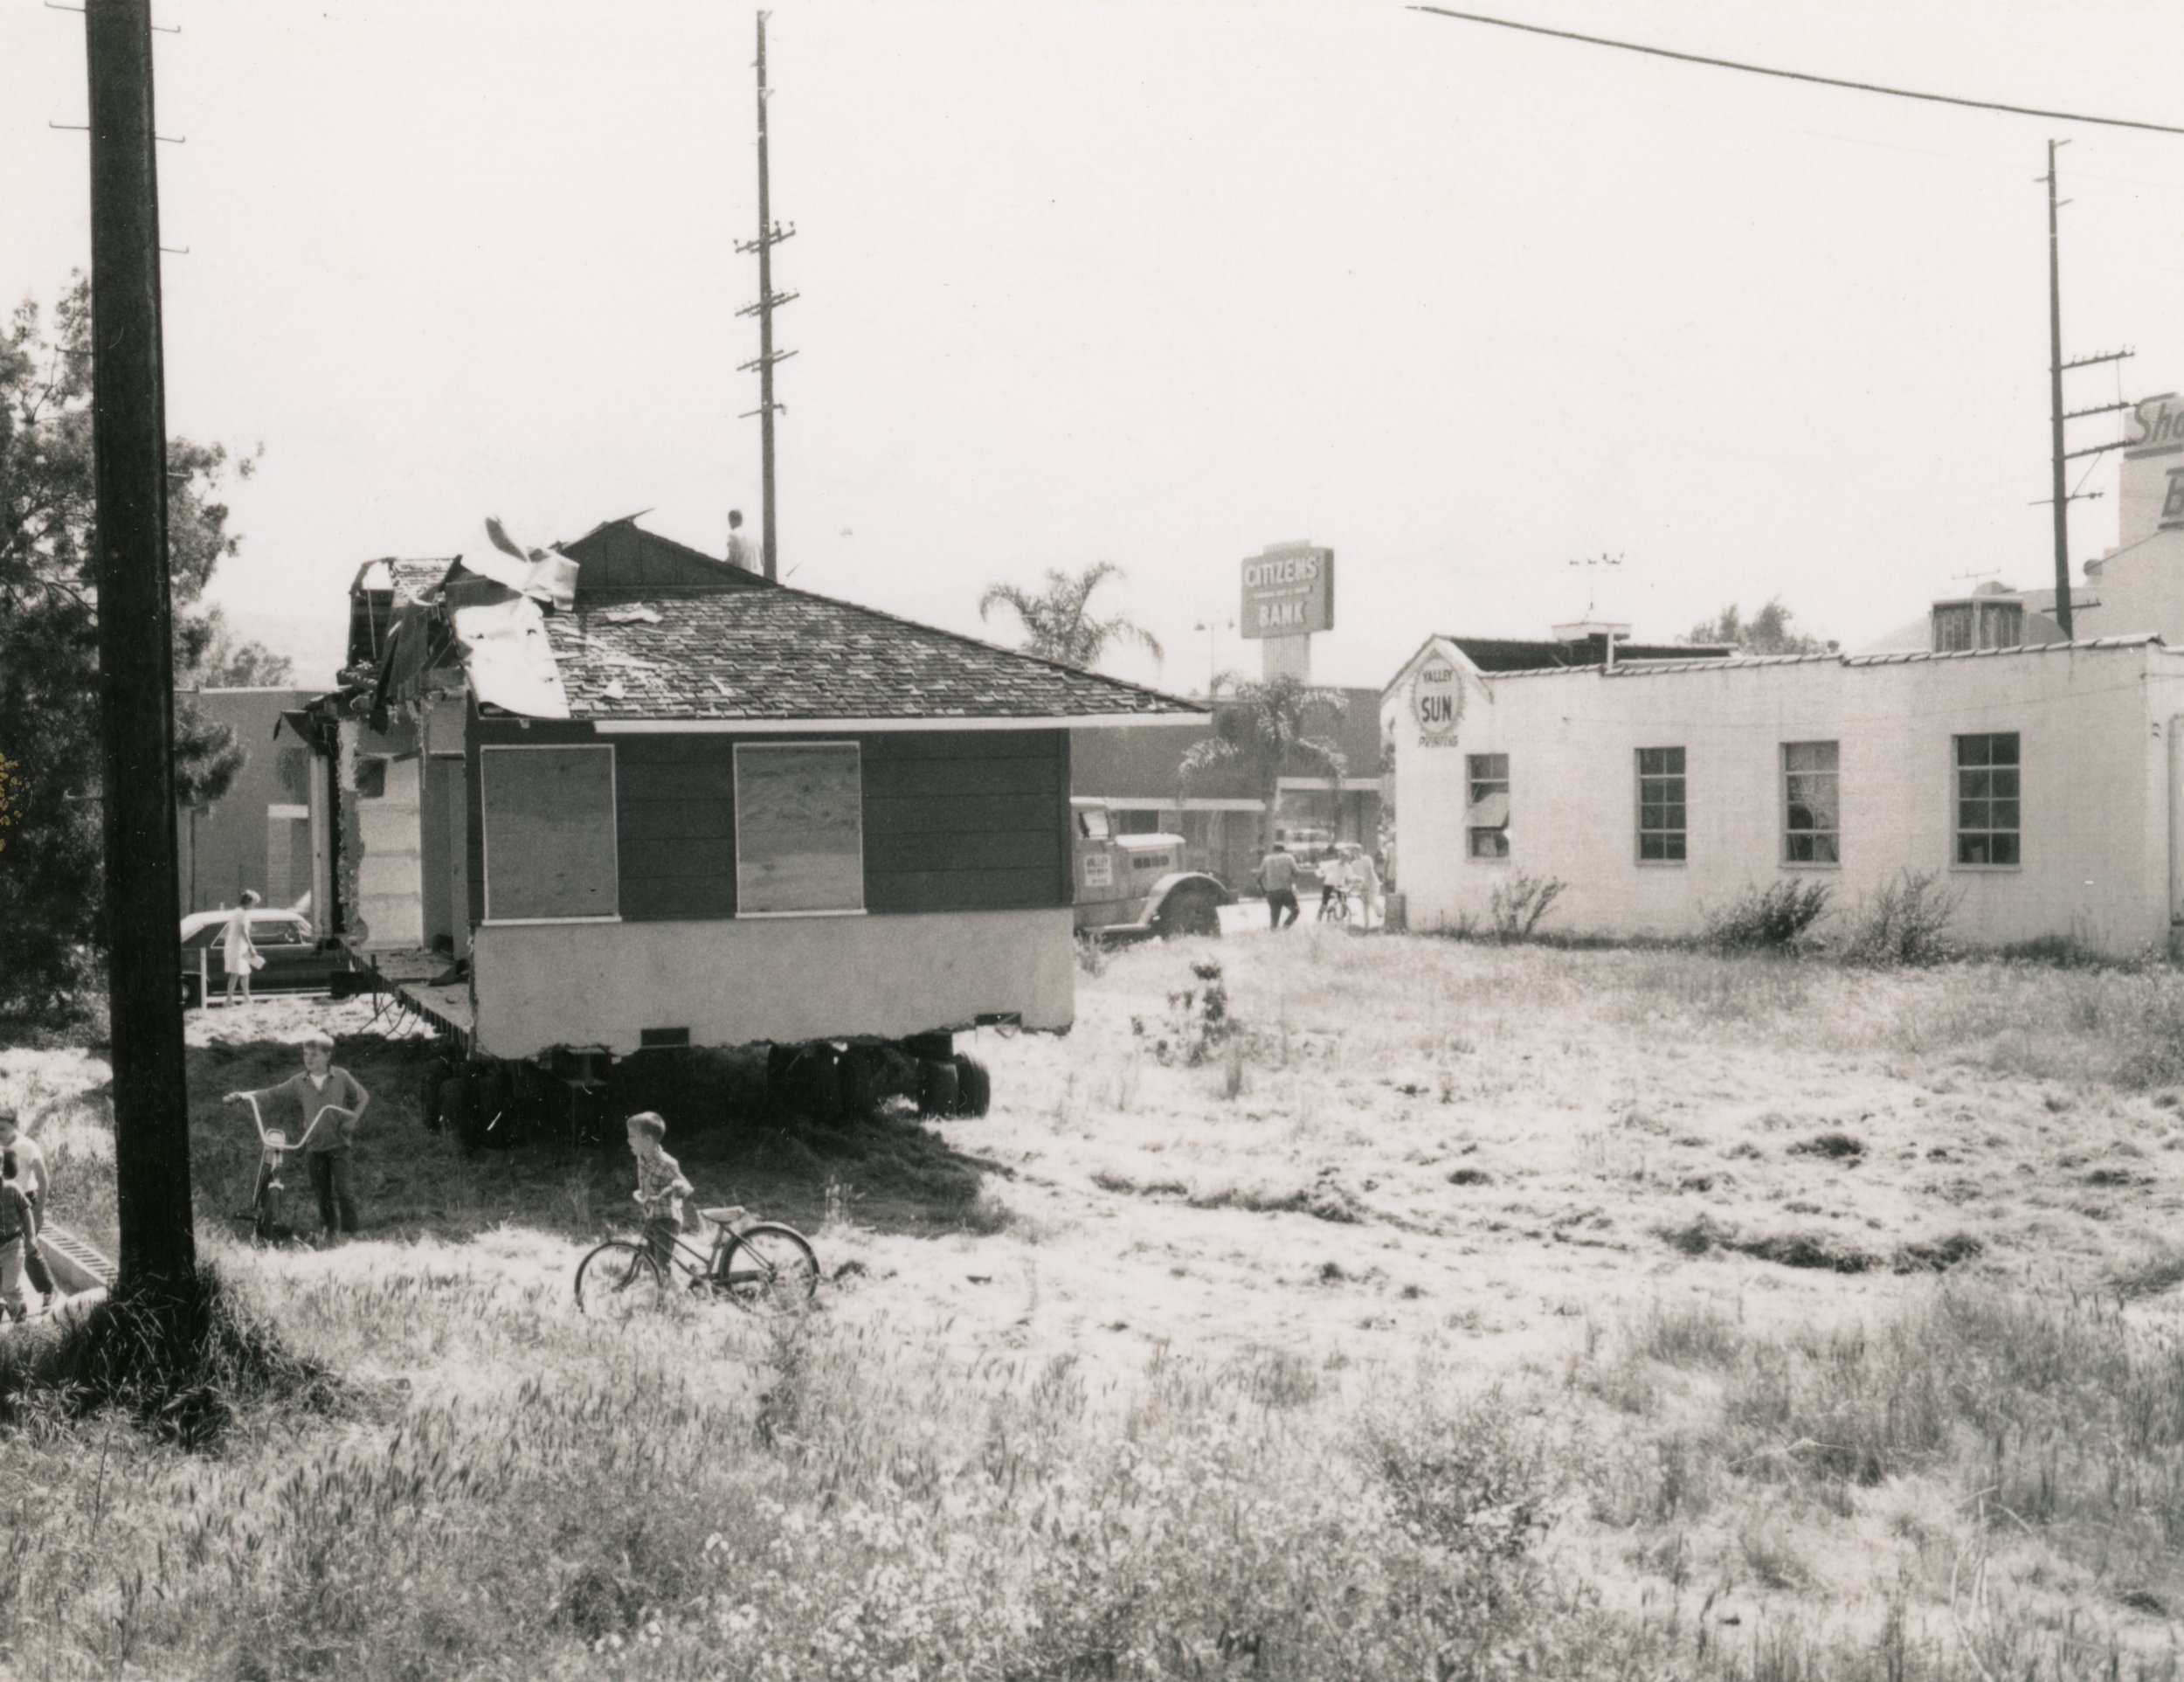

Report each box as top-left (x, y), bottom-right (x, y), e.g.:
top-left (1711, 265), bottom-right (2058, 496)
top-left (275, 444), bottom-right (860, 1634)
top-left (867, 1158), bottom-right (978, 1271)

top-left (736, 743), bottom-right (865, 917)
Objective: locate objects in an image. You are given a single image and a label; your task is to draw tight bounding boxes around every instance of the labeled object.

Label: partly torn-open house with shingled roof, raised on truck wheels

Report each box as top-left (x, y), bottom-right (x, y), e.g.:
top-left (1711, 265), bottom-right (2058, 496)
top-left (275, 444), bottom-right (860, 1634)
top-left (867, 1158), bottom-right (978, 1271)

top-left (312, 520), bottom-right (1204, 1083)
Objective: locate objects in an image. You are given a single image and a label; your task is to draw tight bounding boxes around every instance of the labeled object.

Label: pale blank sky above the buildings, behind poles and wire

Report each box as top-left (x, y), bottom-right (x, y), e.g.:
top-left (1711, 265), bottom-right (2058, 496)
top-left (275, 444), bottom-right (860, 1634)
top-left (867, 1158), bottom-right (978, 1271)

top-left (0, 0), bottom-right (2184, 689)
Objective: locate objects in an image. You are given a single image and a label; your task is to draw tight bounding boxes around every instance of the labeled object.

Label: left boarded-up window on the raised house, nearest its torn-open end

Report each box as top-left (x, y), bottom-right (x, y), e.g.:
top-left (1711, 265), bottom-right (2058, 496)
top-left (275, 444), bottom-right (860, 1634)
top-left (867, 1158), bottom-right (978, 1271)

top-left (479, 747), bottom-right (619, 922)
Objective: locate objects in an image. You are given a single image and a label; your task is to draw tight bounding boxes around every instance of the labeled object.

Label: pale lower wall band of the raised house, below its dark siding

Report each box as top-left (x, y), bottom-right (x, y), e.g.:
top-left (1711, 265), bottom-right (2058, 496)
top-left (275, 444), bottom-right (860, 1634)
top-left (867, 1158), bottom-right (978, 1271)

top-left (472, 907), bottom-right (1077, 1057)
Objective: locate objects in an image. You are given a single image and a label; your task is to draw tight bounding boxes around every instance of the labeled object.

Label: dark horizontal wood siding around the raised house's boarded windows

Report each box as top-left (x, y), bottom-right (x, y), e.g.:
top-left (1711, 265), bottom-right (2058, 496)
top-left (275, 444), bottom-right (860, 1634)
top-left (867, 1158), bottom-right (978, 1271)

top-left (467, 710), bottom-right (1070, 924)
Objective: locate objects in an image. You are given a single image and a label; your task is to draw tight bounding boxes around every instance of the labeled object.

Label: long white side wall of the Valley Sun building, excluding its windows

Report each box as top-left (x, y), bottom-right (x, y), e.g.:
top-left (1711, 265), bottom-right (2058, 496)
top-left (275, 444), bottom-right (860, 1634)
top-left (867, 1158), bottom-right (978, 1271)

top-left (1385, 647), bottom-right (2184, 955)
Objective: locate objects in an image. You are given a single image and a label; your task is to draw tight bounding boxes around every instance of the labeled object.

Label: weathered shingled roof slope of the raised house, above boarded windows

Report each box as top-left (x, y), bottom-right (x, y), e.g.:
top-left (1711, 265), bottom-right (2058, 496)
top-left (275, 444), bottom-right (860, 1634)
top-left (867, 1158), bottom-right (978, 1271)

top-left (533, 585), bottom-right (1206, 723)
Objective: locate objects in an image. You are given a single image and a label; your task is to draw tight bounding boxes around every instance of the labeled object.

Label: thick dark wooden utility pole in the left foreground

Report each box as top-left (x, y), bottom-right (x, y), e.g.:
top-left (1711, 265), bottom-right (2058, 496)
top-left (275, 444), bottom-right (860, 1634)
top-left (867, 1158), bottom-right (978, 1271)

top-left (83, 0), bottom-right (197, 1296)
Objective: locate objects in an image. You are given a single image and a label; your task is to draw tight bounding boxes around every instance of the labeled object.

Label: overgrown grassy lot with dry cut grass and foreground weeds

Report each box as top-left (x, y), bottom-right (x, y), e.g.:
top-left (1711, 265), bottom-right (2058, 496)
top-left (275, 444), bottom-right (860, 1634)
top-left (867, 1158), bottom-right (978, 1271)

top-left (0, 929), bottom-right (2184, 1682)
